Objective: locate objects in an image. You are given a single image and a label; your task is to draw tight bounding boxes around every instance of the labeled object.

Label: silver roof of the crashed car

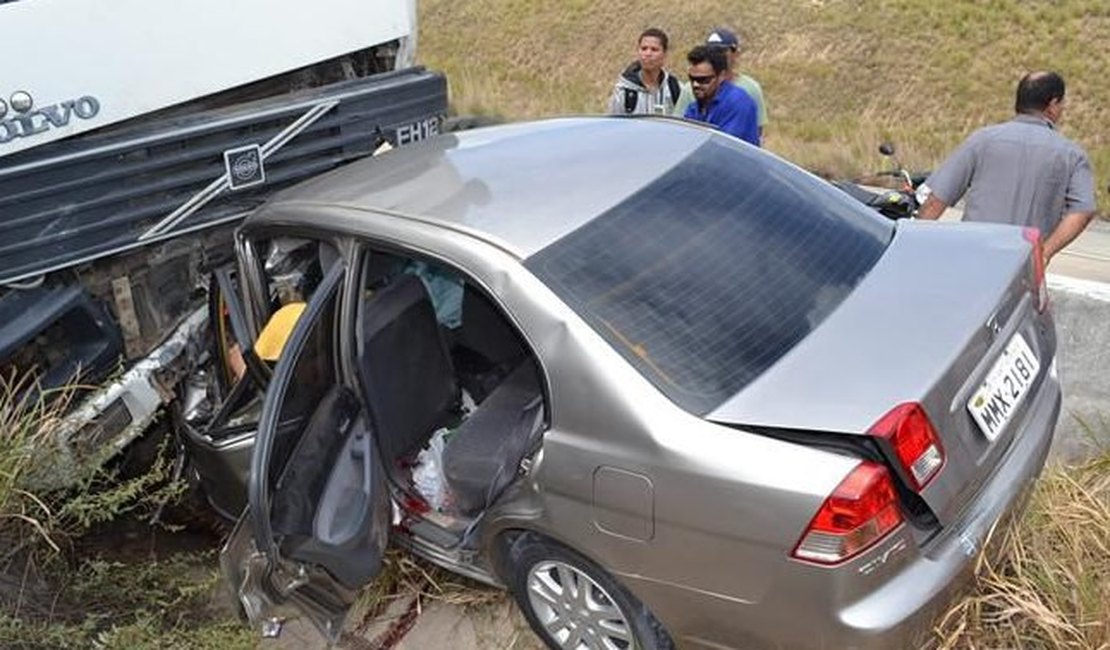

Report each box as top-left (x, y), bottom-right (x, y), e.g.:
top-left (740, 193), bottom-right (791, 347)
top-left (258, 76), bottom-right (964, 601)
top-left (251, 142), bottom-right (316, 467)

top-left (248, 116), bottom-right (726, 258)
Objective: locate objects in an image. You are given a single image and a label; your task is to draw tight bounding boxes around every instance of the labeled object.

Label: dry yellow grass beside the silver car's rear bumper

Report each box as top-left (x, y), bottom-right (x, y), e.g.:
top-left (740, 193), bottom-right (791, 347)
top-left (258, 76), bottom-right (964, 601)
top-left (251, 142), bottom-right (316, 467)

top-left (937, 454), bottom-right (1110, 650)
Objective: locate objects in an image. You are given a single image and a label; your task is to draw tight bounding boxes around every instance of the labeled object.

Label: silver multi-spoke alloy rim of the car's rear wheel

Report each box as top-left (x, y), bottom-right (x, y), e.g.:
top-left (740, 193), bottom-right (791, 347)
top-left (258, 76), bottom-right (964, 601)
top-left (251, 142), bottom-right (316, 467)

top-left (527, 560), bottom-right (635, 650)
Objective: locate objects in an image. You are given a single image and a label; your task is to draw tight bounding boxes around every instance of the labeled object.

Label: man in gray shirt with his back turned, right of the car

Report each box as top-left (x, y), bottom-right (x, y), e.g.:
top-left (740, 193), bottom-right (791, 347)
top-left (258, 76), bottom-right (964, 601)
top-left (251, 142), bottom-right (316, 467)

top-left (918, 72), bottom-right (1096, 264)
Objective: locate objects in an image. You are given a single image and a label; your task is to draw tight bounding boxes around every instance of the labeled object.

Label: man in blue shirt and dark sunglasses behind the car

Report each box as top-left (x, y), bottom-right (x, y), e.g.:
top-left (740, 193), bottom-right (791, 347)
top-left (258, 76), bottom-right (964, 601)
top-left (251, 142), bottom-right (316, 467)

top-left (683, 45), bottom-right (759, 146)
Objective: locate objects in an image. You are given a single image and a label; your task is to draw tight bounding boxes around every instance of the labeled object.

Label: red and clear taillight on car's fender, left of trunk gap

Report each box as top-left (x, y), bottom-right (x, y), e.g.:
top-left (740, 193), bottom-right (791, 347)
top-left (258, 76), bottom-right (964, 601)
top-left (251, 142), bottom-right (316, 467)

top-left (790, 460), bottom-right (902, 565)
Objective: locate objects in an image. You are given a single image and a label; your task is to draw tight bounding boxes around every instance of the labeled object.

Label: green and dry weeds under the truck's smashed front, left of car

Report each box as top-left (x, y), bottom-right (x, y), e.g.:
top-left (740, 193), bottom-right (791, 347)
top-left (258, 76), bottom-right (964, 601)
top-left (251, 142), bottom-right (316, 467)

top-left (0, 375), bottom-right (254, 650)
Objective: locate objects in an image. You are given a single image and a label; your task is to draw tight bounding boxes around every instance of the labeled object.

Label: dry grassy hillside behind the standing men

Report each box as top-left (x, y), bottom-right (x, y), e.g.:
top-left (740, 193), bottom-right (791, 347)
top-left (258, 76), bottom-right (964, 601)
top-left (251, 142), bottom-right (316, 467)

top-left (421, 0), bottom-right (1110, 195)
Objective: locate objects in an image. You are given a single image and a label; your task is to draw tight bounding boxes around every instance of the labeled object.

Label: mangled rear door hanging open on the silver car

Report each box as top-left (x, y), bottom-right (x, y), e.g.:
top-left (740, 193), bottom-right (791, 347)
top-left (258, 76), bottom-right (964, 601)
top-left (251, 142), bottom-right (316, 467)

top-left (221, 261), bottom-right (390, 641)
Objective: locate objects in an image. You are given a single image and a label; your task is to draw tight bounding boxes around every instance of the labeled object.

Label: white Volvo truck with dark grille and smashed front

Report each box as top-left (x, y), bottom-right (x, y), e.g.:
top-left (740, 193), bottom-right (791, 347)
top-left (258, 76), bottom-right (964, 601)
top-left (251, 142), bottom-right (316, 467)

top-left (0, 0), bottom-right (447, 474)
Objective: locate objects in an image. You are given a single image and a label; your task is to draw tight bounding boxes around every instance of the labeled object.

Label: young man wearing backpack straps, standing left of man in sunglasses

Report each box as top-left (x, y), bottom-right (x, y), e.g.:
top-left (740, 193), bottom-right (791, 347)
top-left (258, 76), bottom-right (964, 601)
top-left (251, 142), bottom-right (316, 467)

top-left (609, 27), bottom-right (682, 115)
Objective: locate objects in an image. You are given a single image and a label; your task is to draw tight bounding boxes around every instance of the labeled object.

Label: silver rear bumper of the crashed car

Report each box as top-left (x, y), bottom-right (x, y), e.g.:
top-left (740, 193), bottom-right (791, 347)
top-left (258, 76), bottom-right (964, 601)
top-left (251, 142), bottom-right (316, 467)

top-left (620, 363), bottom-right (1061, 649)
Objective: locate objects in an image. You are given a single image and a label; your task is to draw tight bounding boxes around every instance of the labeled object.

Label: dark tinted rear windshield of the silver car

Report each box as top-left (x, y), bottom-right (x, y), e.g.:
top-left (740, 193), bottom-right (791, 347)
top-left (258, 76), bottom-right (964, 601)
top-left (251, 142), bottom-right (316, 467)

top-left (525, 138), bottom-right (894, 415)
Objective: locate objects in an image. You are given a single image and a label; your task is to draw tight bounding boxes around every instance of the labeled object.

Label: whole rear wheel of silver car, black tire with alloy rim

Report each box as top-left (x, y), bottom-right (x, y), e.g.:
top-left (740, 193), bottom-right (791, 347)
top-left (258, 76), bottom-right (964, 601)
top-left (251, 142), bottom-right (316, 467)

top-left (502, 532), bottom-right (674, 650)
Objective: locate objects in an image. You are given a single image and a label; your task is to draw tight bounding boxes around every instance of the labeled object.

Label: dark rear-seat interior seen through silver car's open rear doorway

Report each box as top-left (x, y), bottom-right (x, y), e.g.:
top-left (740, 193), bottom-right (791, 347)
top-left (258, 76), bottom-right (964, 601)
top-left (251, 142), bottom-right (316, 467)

top-left (357, 248), bottom-right (544, 518)
